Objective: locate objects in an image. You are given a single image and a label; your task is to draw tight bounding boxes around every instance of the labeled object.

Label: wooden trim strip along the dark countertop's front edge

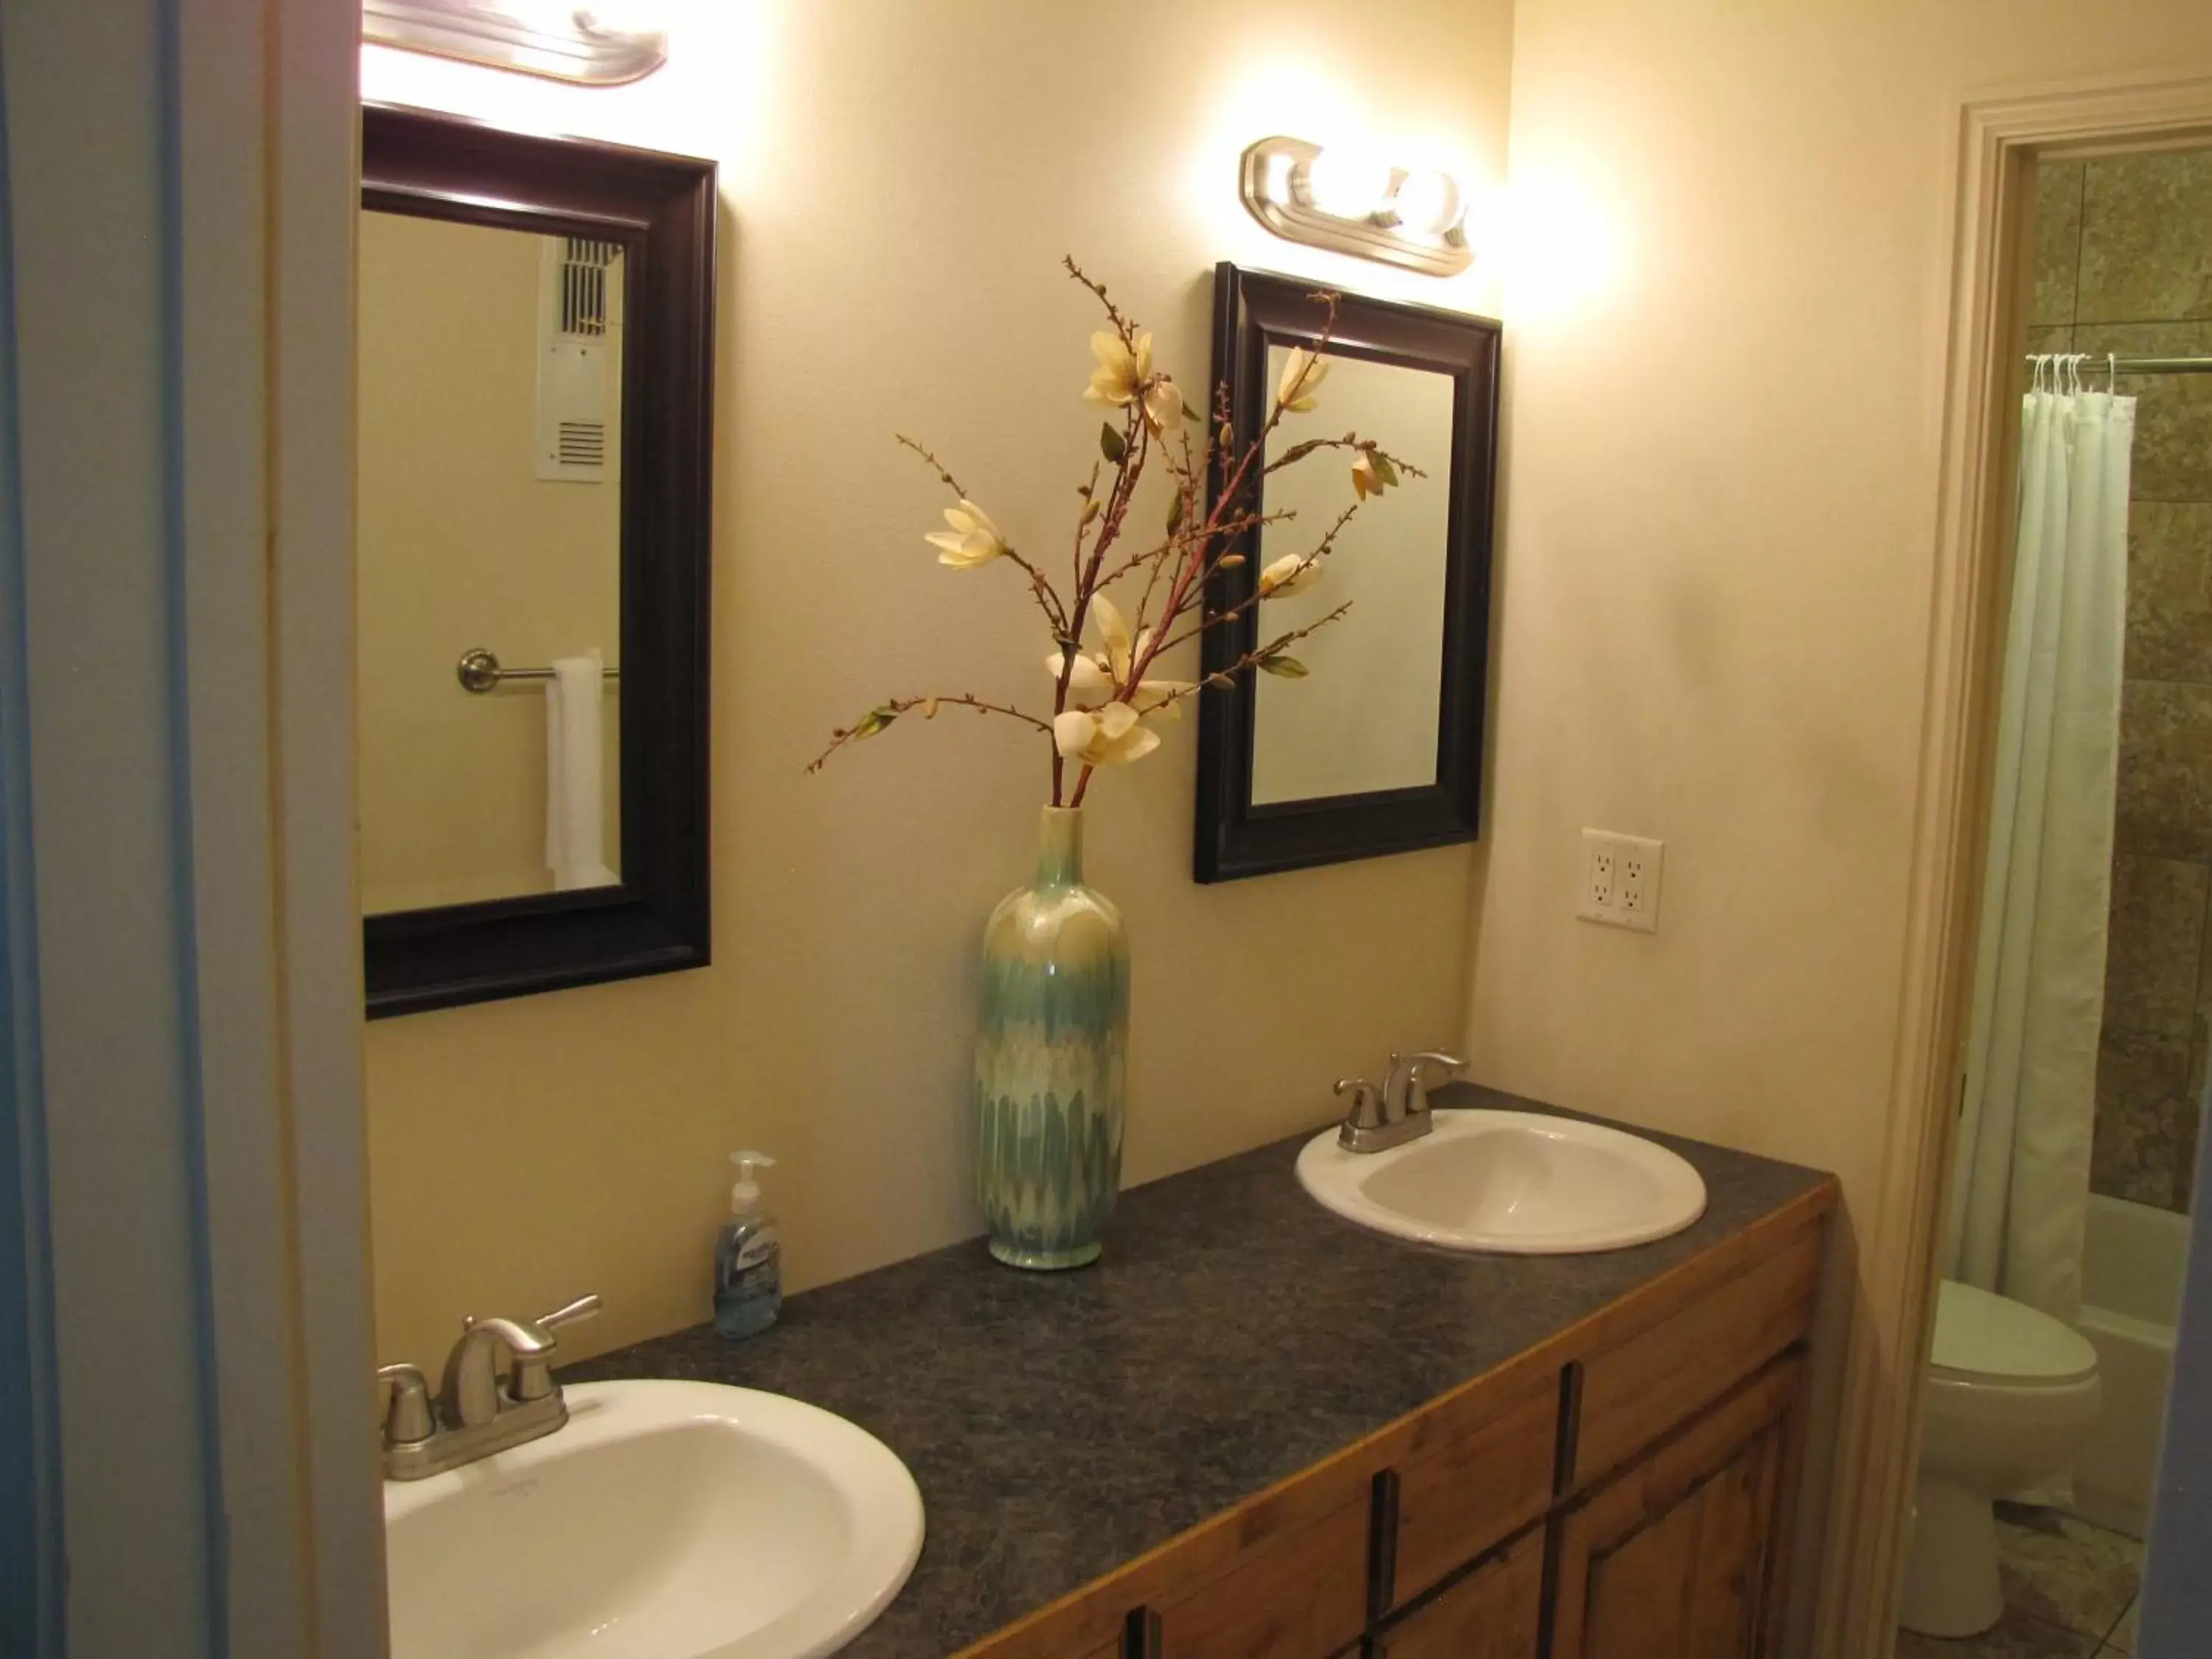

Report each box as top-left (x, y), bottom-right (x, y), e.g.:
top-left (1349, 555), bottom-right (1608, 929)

top-left (953, 1175), bottom-right (1843, 1659)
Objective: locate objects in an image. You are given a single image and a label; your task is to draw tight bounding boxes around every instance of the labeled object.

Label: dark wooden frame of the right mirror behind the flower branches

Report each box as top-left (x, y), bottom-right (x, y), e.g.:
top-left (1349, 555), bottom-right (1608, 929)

top-left (1194, 261), bottom-right (1502, 883)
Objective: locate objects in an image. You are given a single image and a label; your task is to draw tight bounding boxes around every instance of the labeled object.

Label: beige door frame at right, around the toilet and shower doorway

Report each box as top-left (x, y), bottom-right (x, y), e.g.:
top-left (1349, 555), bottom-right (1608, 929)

top-left (1816, 73), bottom-right (2212, 1659)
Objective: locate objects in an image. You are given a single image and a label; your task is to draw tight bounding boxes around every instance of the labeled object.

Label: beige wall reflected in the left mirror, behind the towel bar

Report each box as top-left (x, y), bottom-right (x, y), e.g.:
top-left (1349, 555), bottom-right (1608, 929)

top-left (356, 212), bottom-right (622, 911)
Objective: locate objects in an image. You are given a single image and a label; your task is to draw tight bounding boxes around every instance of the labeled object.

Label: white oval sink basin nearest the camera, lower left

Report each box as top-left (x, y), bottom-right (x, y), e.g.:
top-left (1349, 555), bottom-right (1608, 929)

top-left (385, 1382), bottom-right (922, 1659)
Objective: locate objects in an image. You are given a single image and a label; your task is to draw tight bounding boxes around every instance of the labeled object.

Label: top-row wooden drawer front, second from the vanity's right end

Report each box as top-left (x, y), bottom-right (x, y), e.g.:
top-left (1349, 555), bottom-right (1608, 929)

top-left (1389, 1385), bottom-right (1559, 1606)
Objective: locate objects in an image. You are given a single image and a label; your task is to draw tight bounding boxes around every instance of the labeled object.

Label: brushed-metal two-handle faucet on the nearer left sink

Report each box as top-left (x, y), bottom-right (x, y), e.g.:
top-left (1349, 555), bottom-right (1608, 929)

top-left (376, 1296), bottom-right (599, 1480)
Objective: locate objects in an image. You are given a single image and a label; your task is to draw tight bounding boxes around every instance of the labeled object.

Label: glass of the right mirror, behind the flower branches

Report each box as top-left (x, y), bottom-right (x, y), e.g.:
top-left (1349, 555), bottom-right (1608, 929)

top-left (1252, 345), bottom-right (1453, 805)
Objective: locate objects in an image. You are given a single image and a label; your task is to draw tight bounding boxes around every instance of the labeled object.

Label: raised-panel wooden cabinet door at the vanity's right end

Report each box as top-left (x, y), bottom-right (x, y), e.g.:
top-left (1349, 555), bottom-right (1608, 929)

top-left (1551, 1358), bottom-right (1805, 1659)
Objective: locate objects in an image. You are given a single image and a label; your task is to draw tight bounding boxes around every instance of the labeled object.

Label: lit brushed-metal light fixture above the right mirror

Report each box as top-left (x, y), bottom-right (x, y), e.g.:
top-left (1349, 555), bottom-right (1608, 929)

top-left (1241, 137), bottom-right (1475, 276)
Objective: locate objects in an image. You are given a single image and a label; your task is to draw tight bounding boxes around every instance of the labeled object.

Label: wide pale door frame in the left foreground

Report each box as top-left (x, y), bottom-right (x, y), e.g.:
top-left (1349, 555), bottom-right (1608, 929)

top-left (0, 0), bottom-right (385, 1659)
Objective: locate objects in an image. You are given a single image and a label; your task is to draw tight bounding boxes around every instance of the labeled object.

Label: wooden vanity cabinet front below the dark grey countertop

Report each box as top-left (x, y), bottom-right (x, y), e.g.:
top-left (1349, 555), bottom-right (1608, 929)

top-left (962, 1183), bottom-right (1834, 1659)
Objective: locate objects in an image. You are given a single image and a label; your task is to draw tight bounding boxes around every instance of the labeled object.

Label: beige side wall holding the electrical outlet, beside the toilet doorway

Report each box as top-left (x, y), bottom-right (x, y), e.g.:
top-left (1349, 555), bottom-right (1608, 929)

top-left (1469, 0), bottom-right (2212, 1646)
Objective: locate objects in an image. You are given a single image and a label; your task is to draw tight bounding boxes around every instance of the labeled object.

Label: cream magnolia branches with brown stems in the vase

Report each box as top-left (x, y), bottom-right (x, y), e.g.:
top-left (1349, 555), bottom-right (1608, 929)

top-left (807, 259), bottom-right (1425, 807)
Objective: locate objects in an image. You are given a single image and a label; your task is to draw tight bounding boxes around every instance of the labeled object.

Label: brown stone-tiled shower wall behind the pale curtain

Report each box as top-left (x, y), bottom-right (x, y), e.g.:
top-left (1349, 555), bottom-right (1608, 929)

top-left (2028, 150), bottom-right (2212, 1210)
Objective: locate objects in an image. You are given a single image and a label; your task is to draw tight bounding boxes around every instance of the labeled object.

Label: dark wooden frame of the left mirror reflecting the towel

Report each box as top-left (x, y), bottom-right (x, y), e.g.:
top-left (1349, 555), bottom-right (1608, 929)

top-left (361, 104), bottom-right (717, 1020)
